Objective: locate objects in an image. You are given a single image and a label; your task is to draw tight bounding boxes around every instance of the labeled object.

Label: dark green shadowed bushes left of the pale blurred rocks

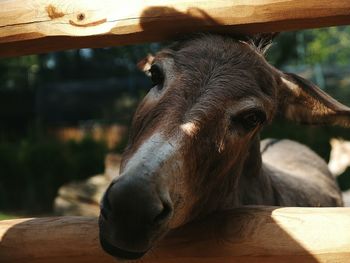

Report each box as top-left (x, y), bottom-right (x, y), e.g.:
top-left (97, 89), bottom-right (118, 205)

top-left (0, 138), bottom-right (107, 212)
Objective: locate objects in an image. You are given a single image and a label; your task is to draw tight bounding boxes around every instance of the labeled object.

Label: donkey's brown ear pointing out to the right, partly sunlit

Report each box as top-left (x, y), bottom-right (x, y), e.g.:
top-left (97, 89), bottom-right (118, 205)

top-left (279, 73), bottom-right (350, 127)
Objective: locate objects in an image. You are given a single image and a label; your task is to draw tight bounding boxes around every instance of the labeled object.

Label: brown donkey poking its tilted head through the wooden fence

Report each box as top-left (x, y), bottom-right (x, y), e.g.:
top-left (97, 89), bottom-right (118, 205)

top-left (99, 35), bottom-right (350, 259)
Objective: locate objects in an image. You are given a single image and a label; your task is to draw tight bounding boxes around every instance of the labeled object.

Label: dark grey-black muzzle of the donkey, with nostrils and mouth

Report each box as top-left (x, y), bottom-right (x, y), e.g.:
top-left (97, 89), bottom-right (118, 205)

top-left (99, 174), bottom-right (173, 259)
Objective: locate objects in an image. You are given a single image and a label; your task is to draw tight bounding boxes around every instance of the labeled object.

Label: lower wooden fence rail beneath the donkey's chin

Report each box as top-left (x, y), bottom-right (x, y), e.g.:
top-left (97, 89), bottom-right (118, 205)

top-left (0, 207), bottom-right (350, 263)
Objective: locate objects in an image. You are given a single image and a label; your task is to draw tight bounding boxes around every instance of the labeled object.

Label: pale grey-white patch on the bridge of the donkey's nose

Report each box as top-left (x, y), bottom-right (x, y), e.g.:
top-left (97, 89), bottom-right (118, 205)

top-left (124, 133), bottom-right (178, 173)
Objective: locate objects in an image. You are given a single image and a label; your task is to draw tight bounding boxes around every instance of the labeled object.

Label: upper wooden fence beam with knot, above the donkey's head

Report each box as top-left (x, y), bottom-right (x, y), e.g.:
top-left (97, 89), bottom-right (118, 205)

top-left (0, 0), bottom-right (350, 57)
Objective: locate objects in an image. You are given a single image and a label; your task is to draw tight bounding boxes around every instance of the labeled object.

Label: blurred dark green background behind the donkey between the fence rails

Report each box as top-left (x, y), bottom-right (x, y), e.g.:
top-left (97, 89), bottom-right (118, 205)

top-left (0, 27), bottom-right (350, 219)
